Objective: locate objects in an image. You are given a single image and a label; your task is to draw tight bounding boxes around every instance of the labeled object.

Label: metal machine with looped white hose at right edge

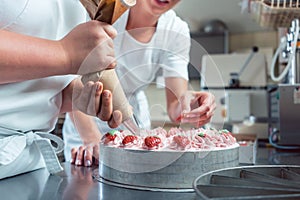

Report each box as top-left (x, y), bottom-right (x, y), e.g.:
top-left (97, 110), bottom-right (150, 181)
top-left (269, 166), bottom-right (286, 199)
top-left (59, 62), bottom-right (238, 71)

top-left (269, 19), bottom-right (300, 148)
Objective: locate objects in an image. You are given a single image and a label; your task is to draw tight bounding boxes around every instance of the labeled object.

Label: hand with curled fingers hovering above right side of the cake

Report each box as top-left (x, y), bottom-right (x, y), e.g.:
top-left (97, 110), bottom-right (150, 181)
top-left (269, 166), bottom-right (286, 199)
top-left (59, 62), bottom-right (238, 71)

top-left (177, 91), bottom-right (216, 127)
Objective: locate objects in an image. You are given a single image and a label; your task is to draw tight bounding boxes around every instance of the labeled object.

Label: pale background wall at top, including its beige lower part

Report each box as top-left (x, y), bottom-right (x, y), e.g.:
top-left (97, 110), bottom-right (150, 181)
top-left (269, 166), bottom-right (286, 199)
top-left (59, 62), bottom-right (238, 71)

top-left (175, 0), bottom-right (279, 52)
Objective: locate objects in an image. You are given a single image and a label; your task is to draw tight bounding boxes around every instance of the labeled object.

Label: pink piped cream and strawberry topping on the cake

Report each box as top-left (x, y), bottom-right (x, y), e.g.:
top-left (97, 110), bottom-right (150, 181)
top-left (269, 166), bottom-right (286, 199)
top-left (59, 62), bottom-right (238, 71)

top-left (102, 127), bottom-right (238, 151)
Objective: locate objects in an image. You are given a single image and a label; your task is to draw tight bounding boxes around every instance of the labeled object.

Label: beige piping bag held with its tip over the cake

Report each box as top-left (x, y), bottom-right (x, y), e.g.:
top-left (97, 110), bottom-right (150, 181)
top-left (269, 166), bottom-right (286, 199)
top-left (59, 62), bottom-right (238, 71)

top-left (80, 0), bottom-right (140, 134)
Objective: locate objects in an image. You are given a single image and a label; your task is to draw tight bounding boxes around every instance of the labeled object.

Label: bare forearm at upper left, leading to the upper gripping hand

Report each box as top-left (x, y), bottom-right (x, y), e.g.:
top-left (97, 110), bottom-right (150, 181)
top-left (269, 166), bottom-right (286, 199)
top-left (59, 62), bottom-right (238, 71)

top-left (0, 30), bottom-right (69, 84)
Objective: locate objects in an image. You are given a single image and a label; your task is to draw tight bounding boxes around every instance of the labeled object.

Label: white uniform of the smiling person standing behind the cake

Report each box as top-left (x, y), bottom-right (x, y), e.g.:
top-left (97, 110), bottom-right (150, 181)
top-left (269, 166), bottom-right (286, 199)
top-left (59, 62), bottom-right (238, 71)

top-left (63, 10), bottom-right (190, 160)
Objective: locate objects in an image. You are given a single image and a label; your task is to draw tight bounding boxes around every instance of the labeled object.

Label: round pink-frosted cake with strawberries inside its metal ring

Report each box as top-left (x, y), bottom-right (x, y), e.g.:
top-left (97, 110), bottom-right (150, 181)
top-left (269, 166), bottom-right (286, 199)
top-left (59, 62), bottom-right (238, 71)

top-left (98, 128), bottom-right (239, 191)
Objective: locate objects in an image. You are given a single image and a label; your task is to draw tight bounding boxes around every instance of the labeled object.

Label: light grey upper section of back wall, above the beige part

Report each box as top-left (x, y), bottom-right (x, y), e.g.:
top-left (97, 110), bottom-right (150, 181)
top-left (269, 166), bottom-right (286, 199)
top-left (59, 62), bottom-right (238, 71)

top-left (171, 0), bottom-right (270, 33)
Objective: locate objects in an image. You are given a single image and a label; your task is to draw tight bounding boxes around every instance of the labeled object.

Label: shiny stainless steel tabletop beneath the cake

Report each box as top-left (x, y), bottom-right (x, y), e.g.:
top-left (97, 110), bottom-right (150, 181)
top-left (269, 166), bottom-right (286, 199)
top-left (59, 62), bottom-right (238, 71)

top-left (0, 148), bottom-right (300, 200)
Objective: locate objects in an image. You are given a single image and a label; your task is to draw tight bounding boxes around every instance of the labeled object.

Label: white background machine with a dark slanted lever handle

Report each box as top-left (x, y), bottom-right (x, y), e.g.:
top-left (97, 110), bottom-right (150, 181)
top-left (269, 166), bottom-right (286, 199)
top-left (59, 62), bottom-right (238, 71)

top-left (201, 51), bottom-right (268, 128)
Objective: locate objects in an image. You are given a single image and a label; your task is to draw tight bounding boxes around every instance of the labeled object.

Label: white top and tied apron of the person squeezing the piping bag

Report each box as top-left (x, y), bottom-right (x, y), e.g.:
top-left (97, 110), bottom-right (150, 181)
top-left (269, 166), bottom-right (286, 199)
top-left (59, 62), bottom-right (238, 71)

top-left (0, 0), bottom-right (87, 179)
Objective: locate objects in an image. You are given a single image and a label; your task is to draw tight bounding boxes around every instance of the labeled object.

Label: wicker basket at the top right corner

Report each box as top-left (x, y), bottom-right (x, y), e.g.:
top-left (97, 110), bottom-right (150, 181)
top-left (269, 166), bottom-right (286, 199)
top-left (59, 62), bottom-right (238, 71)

top-left (251, 0), bottom-right (300, 28)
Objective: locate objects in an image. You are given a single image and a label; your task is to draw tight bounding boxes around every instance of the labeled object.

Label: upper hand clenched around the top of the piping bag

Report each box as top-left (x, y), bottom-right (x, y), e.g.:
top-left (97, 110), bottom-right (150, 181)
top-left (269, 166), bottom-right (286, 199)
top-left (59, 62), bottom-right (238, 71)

top-left (59, 20), bottom-right (116, 75)
